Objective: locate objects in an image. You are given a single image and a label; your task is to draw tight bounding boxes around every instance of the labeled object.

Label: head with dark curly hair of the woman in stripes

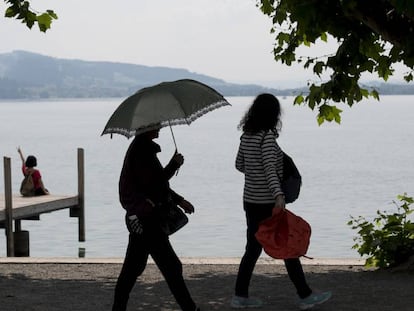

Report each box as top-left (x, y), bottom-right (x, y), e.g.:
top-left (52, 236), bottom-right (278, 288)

top-left (238, 93), bottom-right (281, 133)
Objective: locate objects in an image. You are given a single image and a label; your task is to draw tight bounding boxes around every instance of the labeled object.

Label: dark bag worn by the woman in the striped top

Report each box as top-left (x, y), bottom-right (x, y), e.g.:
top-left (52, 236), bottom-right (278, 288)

top-left (282, 152), bottom-right (302, 203)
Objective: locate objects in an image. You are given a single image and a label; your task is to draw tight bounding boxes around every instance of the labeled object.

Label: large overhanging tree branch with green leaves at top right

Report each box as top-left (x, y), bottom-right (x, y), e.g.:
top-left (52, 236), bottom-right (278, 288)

top-left (257, 0), bottom-right (414, 124)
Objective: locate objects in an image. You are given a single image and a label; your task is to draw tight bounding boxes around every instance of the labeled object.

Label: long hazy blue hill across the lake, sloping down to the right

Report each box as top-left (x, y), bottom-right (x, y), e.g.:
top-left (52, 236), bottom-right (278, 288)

top-left (0, 51), bottom-right (288, 99)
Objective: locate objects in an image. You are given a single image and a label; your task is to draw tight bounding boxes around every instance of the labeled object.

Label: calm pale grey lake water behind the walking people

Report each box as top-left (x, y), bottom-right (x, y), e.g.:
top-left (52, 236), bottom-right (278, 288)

top-left (0, 96), bottom-right (414, 258)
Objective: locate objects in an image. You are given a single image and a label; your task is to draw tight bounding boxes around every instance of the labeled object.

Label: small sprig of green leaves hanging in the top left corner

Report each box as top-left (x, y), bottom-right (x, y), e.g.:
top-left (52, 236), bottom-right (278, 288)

top-left (4, 0), bottom-right (58, 32)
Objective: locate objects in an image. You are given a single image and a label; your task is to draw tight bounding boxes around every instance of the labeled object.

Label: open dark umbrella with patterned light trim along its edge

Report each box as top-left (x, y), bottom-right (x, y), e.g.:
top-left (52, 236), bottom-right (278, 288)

top-left (102, 79), bottom-right (230, 144)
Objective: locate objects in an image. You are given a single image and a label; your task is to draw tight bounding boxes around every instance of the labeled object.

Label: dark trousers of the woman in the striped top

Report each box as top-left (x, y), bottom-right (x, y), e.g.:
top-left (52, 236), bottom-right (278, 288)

top-left (235, 202), bottom-right (312, 298)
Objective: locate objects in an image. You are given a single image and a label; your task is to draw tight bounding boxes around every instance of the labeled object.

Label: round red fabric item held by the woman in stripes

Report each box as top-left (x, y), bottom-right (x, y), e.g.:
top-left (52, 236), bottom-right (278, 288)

top-left (256, 209), bottom-right (311, 259)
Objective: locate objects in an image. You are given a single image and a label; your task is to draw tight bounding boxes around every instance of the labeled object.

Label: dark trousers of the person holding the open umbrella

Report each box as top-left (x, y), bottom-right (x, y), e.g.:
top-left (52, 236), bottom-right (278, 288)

top-left (112, 224), bottom-right (196, 311)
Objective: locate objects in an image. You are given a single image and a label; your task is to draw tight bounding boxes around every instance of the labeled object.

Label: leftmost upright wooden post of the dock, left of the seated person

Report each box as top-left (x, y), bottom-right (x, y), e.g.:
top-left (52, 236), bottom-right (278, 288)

top-left (3, 157), bottom-right (14, 257)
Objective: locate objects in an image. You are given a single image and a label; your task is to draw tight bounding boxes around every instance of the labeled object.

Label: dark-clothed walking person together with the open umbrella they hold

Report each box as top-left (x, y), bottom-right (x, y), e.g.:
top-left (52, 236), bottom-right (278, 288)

top-left (102, 79), bottom-right (230, 311)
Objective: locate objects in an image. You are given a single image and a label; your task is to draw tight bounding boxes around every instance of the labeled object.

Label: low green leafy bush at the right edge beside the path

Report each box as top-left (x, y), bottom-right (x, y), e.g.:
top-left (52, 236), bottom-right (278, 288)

top-left (348, 194), bottom-right (414, 268)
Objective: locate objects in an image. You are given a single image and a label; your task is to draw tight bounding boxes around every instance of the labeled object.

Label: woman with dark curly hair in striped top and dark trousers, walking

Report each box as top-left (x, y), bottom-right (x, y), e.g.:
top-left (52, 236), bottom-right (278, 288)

top-left (231, 94), bottom-right (331, 310)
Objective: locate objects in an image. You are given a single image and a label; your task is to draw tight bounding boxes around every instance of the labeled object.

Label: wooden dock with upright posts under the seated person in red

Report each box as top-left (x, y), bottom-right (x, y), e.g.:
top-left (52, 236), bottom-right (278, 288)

top-left (0, 148), bottom-right (85, 257)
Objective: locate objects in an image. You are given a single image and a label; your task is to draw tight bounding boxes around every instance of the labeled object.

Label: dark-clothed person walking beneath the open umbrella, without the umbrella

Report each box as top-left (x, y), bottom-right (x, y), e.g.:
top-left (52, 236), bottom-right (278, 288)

top-left (112, 128), bottom-right (200, 311)
